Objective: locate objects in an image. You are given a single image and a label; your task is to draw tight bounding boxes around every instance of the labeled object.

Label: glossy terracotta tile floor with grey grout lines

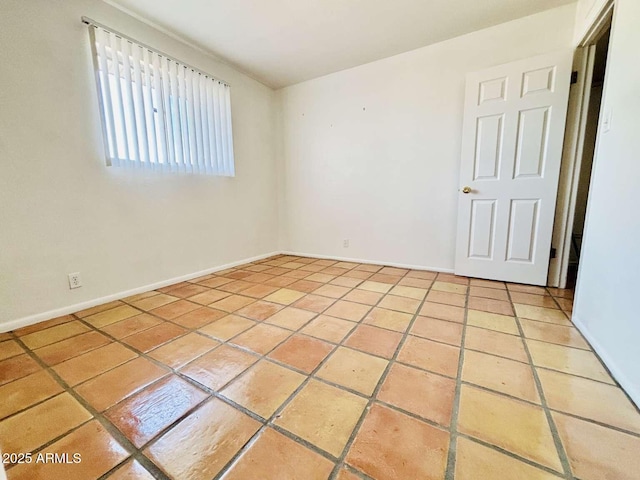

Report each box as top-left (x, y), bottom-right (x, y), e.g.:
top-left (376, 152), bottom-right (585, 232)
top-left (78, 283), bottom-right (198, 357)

top-left (0, 256), bottom-right (640, 480)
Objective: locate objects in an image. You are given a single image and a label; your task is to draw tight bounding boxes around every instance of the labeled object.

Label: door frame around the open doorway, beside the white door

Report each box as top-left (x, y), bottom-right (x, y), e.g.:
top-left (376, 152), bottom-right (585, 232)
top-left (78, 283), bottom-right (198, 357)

top-left (547, 0), bottom-right (614, 288)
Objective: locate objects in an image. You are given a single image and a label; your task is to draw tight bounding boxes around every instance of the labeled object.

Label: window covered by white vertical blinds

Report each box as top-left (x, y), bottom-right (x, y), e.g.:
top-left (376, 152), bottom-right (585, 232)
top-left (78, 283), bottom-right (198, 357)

top-left (89, 23), bottom-right (234, 176)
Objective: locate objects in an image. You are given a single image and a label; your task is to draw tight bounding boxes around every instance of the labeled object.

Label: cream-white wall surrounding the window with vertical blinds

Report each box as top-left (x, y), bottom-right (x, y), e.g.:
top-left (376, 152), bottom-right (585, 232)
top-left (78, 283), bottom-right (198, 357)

top-left (0, 0), bottom-right (278, 331)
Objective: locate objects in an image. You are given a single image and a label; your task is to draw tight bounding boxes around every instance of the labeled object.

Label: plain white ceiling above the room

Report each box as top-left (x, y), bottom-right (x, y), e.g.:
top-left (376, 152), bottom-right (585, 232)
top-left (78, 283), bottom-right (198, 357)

top-left (107, 0), bottom-right (574, 88)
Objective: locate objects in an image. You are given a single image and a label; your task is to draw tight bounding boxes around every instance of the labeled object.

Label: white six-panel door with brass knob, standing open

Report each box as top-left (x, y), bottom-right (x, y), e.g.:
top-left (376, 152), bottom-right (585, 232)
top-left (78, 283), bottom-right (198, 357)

top-left (455, 51), bottom-right (573, 285)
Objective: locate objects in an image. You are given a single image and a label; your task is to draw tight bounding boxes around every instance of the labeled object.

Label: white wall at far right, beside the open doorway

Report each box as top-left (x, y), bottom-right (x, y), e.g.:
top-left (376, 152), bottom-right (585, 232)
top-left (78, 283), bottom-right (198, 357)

top-left (573, 0), bottom-right (640, 405)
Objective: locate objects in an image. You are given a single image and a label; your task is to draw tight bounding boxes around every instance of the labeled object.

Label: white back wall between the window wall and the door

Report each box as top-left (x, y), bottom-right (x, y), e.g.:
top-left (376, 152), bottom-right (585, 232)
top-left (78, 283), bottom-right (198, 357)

top-left (279, 4), bottom-right (575, 270)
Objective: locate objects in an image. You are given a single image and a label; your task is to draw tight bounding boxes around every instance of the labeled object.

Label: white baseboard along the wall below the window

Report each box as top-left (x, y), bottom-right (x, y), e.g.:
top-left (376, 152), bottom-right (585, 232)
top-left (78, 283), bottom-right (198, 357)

top-left (0, 251), bottom-right (280, 333)
